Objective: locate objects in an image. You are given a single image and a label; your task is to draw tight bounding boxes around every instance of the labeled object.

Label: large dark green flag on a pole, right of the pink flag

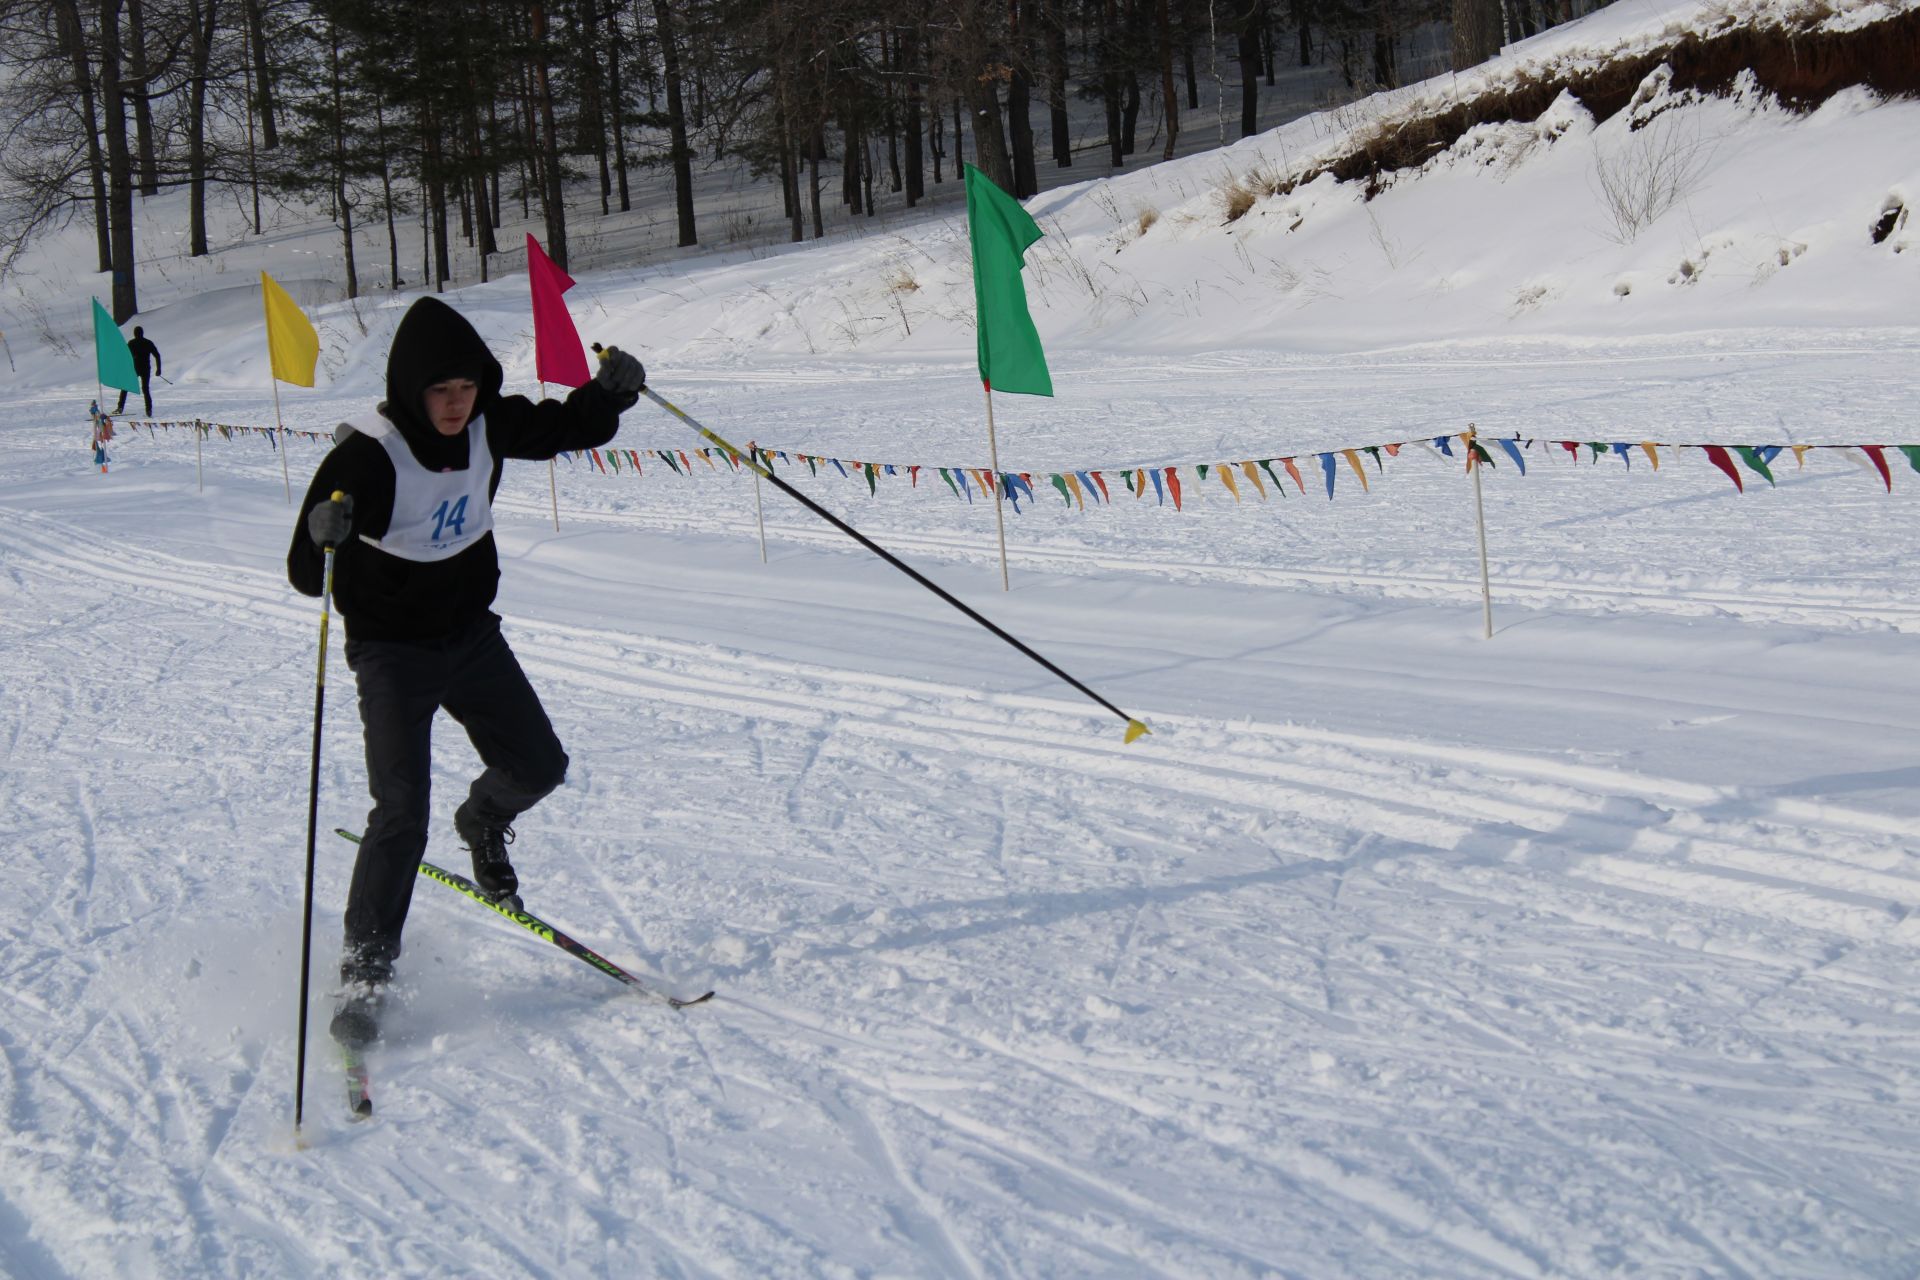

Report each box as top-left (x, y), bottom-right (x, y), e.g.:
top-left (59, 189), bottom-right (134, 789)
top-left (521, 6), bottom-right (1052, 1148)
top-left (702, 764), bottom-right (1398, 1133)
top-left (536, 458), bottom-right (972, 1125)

top-left (966, 165), bottom-right (1054, 395)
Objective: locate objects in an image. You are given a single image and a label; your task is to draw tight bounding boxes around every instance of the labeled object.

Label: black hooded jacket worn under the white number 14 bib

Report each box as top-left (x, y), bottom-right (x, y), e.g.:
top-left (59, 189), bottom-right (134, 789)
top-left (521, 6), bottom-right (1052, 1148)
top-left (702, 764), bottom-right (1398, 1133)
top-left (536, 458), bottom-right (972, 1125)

top-left (286, 297), bottom-right (620, 641)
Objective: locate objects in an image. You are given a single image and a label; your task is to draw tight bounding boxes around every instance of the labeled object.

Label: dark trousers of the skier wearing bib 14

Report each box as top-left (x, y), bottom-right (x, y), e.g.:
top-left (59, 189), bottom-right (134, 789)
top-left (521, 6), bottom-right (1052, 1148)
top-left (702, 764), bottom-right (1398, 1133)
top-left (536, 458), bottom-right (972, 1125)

top-left (346, 614), bottom-right (566, 963)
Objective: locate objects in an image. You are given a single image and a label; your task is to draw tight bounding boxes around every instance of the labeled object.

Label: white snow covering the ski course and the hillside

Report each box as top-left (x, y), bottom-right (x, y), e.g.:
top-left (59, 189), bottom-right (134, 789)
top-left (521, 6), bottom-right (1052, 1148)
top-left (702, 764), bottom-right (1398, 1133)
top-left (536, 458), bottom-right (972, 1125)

top-left (0, 0), bottom-right (1920, 1276)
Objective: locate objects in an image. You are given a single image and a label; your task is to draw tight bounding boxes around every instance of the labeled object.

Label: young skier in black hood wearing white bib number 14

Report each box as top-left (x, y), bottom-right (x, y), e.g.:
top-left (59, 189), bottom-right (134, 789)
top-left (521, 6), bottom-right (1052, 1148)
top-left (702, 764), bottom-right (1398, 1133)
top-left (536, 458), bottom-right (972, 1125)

top-left (286, 297), bottom-right (647, 1038)
